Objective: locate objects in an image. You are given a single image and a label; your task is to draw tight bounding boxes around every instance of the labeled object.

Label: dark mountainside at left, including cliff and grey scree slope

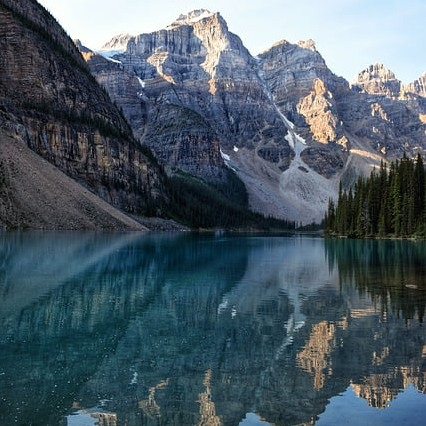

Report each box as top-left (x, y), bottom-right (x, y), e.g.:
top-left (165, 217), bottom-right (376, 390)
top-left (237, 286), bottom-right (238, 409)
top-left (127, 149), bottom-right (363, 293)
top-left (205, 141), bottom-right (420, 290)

top-left (0, 0), bottom-right (166, 229)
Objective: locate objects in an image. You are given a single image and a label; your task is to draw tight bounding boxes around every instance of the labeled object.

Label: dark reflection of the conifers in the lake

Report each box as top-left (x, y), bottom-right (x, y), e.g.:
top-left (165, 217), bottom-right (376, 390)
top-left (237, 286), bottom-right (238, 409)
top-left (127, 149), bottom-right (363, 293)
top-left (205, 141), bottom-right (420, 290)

top-left (325, 239), bottom-right (426, 321)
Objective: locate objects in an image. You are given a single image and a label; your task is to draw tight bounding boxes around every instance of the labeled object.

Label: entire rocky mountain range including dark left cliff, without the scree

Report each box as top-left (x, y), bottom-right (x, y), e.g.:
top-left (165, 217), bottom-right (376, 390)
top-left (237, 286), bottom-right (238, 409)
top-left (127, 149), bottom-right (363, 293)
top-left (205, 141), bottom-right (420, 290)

top-left (0, 0), bottom-right (426, 226)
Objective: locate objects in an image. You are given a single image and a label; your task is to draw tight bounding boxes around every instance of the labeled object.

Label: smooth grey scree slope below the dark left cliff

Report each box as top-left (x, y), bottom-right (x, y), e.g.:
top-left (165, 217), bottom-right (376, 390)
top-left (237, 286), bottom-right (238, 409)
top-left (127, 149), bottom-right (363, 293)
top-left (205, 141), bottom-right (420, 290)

top-left (0, 131), bottom-right (146, 230)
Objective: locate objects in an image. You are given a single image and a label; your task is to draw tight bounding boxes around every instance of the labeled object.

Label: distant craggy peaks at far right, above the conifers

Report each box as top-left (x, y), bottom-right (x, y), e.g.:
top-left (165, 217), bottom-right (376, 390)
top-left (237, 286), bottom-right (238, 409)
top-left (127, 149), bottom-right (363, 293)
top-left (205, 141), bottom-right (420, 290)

top-left (339, 64), bottom-right (426, 174)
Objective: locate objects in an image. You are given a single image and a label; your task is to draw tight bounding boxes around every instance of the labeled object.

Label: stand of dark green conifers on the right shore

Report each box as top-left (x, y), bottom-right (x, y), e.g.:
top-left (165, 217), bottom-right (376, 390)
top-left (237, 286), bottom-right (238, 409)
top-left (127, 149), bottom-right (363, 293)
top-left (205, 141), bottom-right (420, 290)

top-left (324, 155), bottom-right (426, 238)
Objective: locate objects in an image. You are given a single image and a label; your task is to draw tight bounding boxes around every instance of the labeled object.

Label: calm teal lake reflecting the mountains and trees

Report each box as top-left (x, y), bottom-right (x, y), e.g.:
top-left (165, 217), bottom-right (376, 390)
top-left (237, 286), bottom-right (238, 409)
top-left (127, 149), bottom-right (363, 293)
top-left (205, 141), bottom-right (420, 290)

top-left (0, 232), bottom-right (426, 426)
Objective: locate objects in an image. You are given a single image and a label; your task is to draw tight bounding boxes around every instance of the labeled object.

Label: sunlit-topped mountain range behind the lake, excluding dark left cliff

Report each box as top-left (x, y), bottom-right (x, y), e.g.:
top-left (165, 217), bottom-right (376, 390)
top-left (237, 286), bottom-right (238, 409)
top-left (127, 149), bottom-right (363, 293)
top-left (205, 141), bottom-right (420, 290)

top-left (81, 9), bottom-right (426, 223)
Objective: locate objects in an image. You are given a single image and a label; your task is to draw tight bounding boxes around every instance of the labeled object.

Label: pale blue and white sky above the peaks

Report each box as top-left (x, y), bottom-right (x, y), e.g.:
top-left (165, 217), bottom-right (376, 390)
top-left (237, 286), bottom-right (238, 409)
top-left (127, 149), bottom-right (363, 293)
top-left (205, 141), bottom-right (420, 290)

top-left (39, 0), bottom-right (426, 83)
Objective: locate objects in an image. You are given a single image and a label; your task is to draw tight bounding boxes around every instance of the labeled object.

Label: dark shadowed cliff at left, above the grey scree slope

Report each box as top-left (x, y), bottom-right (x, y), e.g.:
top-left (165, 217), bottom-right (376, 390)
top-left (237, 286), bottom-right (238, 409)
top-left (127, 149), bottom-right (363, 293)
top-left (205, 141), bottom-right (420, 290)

top-left (0, 0), bottom-right (166, 230)
